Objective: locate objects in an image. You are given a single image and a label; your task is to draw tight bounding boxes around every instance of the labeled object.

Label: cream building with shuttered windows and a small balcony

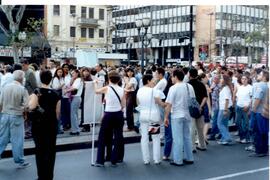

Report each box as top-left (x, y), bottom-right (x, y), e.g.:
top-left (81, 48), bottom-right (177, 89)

top-left (45, 5), bottom-right (112, 58)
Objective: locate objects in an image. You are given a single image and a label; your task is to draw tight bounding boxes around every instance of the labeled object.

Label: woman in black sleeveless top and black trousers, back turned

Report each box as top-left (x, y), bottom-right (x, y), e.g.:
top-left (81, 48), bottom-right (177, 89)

top-left (29, 70), bottom-right (61, 180)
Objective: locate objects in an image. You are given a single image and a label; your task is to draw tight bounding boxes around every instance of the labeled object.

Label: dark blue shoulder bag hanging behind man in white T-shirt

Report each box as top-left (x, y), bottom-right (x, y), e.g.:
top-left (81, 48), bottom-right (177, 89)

top-left (186, 84), bottom-right (201, 119)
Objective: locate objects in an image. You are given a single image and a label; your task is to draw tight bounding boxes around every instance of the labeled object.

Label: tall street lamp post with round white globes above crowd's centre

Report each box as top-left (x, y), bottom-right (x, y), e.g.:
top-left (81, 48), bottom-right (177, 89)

top-left (135, 18), bottom-right (152, 74)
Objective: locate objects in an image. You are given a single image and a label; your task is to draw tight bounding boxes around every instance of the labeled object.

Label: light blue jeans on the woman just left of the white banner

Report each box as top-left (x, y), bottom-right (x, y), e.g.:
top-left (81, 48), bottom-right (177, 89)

top-left (70, 96), bottom-right (81, 133)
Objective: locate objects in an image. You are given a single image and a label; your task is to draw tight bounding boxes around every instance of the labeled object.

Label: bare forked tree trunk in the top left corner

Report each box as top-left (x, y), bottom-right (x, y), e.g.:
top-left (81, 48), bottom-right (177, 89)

top-left (0, 5), bottom-right (26, 63)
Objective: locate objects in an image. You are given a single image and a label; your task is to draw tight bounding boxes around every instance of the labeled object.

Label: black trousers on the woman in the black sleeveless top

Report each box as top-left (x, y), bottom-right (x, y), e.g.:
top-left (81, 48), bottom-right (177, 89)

top-left (32, 123), bottom-right (57, 180)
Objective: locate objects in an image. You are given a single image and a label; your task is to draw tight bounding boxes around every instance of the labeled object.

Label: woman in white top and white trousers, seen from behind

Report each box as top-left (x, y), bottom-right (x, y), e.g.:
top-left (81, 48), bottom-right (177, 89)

top-left (137, 74), bottom-right (164, 164)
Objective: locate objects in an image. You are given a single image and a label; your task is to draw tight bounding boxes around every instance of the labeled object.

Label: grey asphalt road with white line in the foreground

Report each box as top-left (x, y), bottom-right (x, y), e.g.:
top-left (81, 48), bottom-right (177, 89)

top-left (0, 142), bottom-right (269, 180)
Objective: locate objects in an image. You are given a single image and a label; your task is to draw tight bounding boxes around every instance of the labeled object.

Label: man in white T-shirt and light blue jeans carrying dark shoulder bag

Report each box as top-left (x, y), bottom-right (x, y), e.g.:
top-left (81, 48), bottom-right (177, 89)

top-left (164, 70), bottom-right (195, 166)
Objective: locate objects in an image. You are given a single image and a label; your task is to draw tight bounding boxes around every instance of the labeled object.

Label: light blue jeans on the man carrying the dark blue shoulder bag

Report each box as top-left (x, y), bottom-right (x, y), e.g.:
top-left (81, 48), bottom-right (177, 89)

top-left (171, 118), bottom-right (194, 164)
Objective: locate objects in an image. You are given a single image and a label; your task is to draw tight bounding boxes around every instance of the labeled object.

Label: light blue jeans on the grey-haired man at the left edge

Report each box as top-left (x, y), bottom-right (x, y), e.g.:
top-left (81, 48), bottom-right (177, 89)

top-left (0, 113), bottom-right (24, 164)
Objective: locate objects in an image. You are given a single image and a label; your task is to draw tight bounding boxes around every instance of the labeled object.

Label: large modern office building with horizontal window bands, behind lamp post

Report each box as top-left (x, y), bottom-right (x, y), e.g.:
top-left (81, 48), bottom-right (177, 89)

top-left (113, 5), bottom-right (269, 64)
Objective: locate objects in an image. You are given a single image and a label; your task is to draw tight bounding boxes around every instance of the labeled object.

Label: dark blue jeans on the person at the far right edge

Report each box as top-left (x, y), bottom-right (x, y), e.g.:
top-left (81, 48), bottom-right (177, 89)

top-left (254, 113), bottom-right (269, 154)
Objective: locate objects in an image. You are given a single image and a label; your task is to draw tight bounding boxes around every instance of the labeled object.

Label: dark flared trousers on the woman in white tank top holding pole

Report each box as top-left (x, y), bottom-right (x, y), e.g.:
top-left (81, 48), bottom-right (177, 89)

top-left (96, 111), bottom-right (124, 164)
